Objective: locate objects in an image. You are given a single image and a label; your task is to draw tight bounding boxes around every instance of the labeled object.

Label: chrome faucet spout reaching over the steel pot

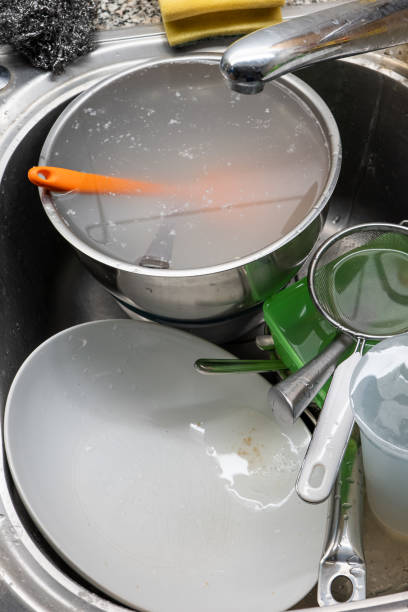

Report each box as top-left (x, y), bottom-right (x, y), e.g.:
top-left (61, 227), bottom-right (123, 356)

top-left (221, 0), bottom-right (408, 94)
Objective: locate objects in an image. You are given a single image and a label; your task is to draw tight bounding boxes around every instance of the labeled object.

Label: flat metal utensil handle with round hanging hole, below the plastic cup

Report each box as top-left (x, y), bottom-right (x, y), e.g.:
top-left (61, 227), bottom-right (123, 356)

top-left (317, 440), bottom-right (366, 606)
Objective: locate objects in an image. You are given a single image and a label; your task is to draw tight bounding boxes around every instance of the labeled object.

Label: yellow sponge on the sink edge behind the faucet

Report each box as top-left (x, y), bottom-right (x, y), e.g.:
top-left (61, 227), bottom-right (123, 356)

top-left (159, 0), bottom-right (285, 46)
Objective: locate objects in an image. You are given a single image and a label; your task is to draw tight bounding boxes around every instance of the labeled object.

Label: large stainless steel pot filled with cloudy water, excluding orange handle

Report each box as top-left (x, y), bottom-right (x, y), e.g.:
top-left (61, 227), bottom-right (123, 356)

top-left (35, 54), bottom-right (341, 322)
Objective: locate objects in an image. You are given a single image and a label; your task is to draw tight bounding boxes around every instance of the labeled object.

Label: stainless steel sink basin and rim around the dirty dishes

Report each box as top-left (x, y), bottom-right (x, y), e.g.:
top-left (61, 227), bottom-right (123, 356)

top-left (0, 13), bottom-right (408, 612)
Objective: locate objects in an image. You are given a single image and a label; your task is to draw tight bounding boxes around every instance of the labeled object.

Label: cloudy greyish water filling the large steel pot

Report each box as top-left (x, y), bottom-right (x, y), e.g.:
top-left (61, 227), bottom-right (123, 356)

top-left (46, 63), bottom-right (329, 269)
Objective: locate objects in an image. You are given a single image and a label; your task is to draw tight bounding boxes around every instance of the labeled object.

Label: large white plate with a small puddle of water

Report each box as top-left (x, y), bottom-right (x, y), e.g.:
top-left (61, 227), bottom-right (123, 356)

top-left (5, 320), bottom-right (327, 612)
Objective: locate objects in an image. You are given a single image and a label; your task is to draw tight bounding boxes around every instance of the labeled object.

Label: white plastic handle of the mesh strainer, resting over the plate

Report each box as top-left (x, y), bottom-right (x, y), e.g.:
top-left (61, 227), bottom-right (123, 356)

top-left (296, 352), bottom-right (361, 504)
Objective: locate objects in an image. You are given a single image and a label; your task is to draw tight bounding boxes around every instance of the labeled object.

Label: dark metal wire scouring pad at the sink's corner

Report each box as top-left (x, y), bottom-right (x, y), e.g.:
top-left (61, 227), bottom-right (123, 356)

top-left (0, 0), bottom-right (96, 74)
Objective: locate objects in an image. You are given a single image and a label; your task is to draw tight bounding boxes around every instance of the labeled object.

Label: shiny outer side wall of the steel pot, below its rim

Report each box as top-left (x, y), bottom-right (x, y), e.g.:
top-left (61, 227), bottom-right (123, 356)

top-left (75, 186), bottom-right (328, 324)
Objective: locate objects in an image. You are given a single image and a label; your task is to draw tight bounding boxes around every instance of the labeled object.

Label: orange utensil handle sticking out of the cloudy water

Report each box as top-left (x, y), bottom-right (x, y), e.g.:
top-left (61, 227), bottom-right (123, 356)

top-left (28, 166), bottom-right (169, 195)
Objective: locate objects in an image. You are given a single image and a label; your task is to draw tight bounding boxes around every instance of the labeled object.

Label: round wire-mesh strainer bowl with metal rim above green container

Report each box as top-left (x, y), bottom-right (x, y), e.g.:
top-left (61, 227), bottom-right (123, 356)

top-left (309, 225), bottom-right (408, 338)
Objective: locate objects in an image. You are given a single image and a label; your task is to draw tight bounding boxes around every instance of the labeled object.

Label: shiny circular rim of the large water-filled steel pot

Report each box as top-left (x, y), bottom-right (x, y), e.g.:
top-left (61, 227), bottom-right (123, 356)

top-left (39, 52), bottom-right (342, 278)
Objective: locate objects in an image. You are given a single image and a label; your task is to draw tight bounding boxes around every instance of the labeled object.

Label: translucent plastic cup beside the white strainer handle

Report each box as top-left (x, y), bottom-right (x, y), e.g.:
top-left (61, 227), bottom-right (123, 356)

top-left (350, 333), bottom-right (408, 537)
